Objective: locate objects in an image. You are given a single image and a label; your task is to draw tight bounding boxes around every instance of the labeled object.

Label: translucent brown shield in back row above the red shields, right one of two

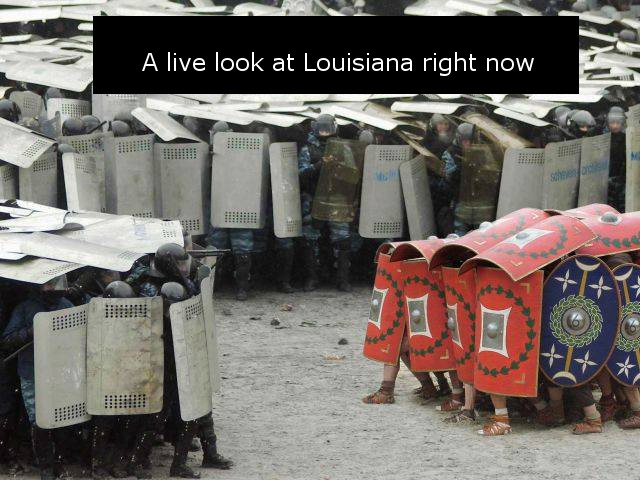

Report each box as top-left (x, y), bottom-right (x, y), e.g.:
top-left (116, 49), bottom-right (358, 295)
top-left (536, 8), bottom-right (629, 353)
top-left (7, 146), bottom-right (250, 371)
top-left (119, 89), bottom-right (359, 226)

top-left (456, 144), bottom-right (502, 225)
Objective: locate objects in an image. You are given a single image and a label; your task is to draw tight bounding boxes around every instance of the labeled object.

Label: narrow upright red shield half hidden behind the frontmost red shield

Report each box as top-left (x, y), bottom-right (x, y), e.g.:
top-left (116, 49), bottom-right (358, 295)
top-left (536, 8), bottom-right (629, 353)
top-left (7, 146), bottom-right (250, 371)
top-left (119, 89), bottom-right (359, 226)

top-left (442, 267), bottom-right (476, 384)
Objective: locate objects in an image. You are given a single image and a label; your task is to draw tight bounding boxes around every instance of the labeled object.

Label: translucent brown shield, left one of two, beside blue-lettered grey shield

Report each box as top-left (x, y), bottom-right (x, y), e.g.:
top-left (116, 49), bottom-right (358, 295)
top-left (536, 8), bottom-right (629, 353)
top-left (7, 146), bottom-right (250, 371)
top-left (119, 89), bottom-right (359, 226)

top-left (311, 138), bottom-right (366, 222)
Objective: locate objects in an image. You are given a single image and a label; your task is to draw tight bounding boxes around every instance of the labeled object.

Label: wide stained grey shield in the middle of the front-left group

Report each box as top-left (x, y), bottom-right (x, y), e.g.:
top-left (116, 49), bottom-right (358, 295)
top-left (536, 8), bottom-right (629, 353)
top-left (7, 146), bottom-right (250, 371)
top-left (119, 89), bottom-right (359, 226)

top-left (87, 297), bottom-right (164, 415)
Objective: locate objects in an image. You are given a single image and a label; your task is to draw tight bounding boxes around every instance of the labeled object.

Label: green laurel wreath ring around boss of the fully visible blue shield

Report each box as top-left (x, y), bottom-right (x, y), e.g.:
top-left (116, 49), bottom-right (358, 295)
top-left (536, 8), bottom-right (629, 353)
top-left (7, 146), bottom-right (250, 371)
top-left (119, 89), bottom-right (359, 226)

top-left (550, 295), bottom-right (602, 347)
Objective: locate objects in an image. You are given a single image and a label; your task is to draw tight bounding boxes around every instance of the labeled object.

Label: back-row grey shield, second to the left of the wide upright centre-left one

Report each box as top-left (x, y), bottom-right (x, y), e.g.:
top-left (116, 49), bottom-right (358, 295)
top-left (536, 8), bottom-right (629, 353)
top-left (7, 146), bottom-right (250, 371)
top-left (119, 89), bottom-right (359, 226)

top-left (104, 134), bottom-right (155, 218)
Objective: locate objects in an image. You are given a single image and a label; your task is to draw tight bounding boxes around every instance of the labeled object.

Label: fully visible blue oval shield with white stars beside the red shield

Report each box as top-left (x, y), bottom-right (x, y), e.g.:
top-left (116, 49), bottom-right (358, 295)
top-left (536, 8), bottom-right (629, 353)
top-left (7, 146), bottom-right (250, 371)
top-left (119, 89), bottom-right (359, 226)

top-left (540, 255), bottom-right (620, 387)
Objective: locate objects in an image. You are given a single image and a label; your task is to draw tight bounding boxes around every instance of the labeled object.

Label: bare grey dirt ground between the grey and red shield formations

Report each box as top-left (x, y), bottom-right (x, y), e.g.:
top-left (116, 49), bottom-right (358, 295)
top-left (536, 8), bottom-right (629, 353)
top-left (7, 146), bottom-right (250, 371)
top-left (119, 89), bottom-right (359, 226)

top-left (3, 285), bottom-right (640, 480)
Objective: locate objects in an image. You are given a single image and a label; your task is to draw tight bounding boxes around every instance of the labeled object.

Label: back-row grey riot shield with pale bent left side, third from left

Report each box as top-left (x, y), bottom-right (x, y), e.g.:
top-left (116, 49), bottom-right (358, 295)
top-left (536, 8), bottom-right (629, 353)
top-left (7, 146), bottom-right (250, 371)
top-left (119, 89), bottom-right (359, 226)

top-left (62, 153), bottom-right (106, 212)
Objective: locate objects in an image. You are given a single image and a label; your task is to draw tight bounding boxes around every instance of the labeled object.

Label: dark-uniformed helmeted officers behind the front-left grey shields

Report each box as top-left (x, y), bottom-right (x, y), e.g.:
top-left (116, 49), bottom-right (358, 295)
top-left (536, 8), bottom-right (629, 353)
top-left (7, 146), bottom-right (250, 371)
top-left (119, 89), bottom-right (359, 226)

top-left (0, 244), bottom-right (232, 480)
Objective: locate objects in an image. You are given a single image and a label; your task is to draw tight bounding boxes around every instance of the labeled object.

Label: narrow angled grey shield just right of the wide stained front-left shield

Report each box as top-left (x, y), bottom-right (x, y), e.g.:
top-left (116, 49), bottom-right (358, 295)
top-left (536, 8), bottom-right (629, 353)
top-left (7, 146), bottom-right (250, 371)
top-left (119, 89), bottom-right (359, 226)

top-left (169, 295), bottom-right (212, 421)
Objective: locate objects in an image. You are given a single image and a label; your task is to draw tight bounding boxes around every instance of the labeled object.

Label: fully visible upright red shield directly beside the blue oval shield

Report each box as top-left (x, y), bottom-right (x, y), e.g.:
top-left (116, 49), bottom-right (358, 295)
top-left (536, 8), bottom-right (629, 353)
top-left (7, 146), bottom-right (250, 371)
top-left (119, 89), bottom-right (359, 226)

top-left (474, 267), bottom-right (544, 397)
